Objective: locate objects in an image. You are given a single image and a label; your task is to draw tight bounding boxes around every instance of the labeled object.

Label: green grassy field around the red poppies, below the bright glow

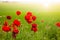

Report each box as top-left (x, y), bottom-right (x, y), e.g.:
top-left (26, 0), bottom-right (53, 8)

top-left (0, 3), bottom-right (60, 40)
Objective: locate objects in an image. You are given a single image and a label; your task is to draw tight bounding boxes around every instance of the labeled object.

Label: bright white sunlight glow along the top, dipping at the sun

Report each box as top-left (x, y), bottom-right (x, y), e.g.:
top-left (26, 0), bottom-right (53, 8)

top-left (0, 0), bottom-right (60, 8)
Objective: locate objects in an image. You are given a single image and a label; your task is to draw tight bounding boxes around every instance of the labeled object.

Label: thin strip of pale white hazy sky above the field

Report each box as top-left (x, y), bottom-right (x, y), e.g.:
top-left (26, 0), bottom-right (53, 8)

top-left (0, 0), bottom-right (60, 3)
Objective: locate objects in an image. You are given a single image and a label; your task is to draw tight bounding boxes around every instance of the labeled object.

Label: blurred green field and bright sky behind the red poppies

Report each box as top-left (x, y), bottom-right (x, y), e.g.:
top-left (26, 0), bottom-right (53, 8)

top-left (0, 0), bottom-right (60, 40)
